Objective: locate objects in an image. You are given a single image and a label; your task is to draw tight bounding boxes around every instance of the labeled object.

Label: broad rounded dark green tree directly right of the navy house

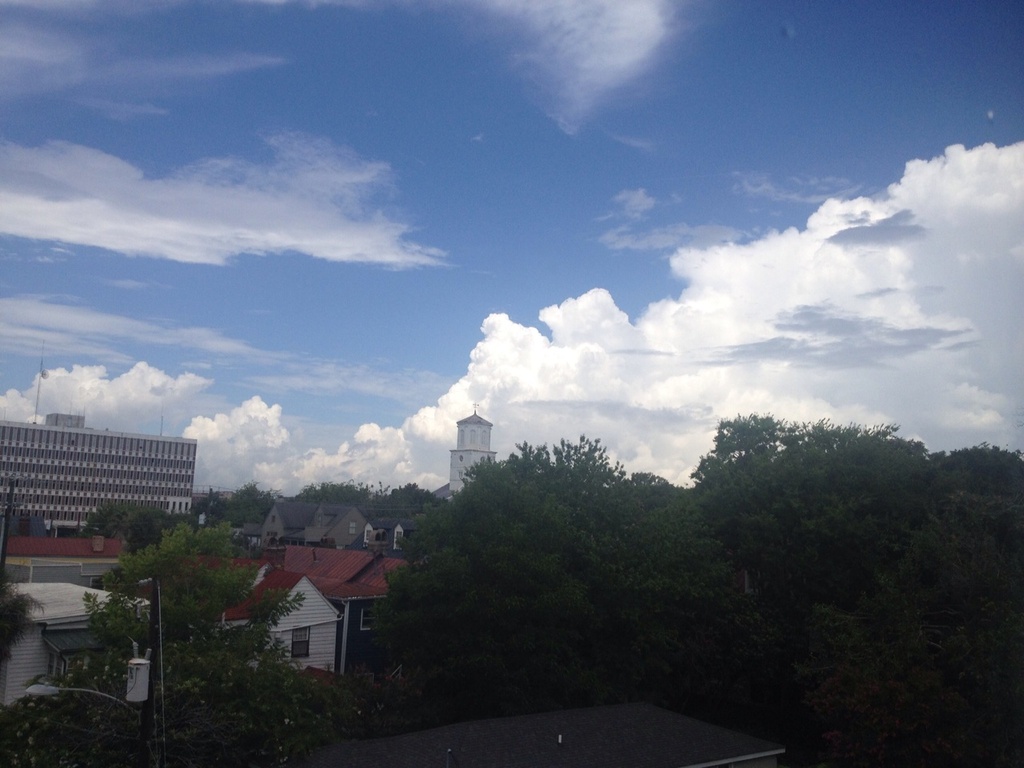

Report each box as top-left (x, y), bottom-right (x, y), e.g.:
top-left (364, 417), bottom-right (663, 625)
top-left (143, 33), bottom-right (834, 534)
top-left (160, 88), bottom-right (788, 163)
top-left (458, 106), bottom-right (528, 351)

top-left (378, 437), bottom-right (736, 720)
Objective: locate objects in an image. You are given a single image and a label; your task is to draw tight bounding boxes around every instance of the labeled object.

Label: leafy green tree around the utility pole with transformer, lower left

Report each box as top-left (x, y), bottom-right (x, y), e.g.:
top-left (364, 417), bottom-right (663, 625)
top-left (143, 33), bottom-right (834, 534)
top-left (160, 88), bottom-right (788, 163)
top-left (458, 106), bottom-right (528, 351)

top-left (0, 525), bottom-right (354, 768)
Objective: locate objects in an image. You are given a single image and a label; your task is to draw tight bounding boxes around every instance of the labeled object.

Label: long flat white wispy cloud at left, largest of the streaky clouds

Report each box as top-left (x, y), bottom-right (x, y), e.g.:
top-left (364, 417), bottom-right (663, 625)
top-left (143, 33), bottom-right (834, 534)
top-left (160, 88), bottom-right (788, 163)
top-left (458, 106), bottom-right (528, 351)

top-left (0, 134), bottom-right (442, 268)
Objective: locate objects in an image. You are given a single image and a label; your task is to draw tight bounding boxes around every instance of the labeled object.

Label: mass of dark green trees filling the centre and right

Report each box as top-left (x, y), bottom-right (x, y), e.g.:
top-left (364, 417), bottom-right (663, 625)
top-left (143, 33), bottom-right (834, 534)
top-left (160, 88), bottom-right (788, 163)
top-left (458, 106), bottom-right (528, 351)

top-left (380, 423), bottom-right (1024, 768)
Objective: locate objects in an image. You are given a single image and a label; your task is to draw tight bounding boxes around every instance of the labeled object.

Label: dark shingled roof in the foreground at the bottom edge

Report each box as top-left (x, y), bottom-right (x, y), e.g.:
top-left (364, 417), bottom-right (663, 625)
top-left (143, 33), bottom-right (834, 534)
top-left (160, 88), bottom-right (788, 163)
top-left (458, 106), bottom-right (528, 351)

top-left (295, 703), bottom-right (785, 768)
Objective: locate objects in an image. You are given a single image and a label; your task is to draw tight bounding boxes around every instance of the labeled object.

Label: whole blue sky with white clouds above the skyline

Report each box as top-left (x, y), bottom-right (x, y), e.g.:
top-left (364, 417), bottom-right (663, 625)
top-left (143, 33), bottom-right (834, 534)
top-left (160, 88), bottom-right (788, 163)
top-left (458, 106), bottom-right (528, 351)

top-left (0, 0), bottom-right (1024, 494)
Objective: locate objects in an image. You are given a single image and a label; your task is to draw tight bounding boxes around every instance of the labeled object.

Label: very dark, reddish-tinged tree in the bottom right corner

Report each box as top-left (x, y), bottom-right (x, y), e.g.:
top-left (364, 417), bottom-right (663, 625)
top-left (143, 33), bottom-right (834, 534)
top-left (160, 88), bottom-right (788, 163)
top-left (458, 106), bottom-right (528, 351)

top-left (802, 495), bottom-right (1024, 768)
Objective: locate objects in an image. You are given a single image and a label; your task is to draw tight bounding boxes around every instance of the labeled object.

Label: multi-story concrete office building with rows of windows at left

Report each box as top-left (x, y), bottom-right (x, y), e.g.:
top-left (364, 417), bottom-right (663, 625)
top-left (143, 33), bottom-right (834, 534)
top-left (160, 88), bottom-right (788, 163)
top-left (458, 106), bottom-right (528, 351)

top-left (0, 414), bottom-right (196, 528)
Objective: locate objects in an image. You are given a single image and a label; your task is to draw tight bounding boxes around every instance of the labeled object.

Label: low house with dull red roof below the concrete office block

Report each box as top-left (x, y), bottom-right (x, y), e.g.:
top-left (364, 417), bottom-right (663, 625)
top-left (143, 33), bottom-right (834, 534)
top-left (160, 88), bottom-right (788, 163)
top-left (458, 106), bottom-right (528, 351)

top-left (7, 536), bottom-right (123, 589)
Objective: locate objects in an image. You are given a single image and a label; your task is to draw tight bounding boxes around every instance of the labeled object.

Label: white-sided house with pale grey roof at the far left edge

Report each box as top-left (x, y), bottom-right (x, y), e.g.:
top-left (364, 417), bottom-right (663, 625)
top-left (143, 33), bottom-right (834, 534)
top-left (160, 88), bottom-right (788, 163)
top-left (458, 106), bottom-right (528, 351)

top-left (0, 581), bottom-right (110, 705)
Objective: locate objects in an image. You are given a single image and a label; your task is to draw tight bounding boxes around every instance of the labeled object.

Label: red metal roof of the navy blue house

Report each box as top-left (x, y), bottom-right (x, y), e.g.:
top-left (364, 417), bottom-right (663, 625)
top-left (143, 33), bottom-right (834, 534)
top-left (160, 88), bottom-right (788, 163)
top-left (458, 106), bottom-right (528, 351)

top-left (264, 546), bottom-right (406, 600)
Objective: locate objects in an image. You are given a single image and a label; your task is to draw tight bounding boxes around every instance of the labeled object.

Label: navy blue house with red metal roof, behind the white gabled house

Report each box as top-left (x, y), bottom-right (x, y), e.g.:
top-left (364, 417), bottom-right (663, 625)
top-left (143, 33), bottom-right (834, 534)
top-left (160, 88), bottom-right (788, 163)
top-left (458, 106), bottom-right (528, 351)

top-left (263, 546), bottom-right (406, 675)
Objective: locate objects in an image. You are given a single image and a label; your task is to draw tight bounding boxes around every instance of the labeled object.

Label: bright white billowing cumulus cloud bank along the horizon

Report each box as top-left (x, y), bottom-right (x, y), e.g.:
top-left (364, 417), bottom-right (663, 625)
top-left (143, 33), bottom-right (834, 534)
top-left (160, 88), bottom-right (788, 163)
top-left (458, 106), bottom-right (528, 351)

top-left (0, 142), bottom-right (1024, 493)
